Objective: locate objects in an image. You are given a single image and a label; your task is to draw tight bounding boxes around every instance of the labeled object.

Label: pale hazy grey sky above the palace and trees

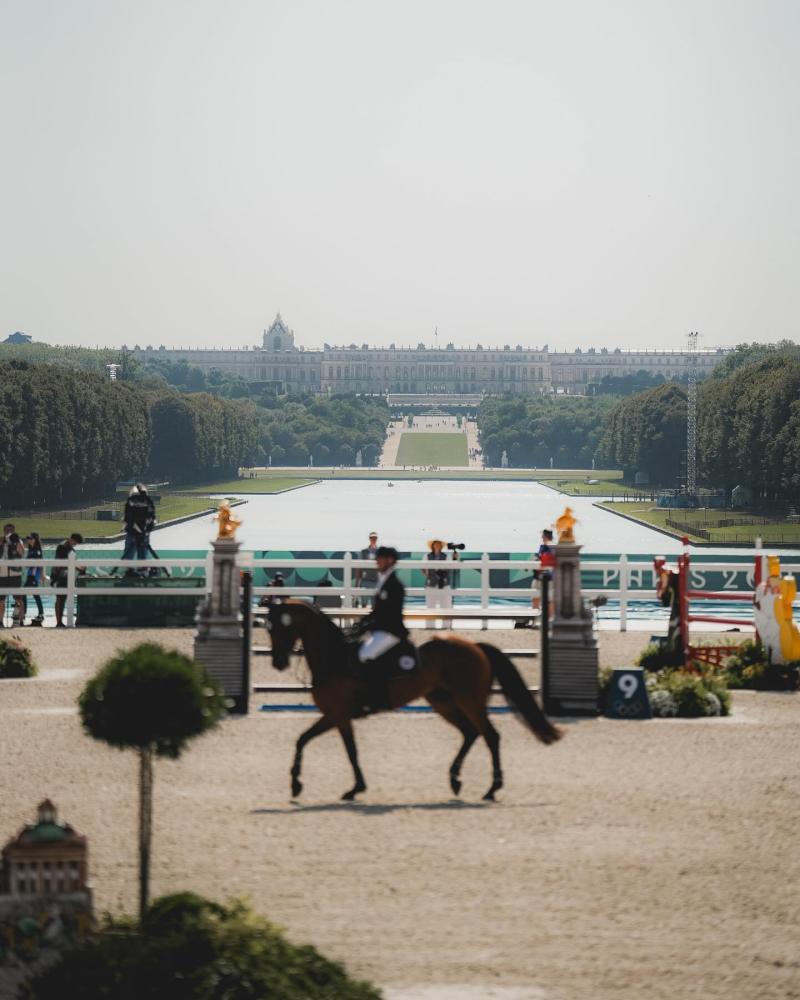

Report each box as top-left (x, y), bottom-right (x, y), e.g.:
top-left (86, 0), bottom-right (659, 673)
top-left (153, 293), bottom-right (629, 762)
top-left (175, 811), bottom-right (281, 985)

top-left (0, 0), bottom-right (800, 348)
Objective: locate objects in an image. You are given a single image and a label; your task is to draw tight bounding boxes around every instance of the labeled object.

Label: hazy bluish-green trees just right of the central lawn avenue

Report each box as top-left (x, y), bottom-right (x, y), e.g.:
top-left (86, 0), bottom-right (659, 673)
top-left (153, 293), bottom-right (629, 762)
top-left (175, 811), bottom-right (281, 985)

top-left (478, 396), bottom-right (615, 469)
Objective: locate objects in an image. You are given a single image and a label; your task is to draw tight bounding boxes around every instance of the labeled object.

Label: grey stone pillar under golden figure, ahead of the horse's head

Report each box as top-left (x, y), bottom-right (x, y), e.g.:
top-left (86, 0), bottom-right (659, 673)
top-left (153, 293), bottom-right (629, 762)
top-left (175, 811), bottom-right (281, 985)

top-left (194, 538), bottom-right (250, 714)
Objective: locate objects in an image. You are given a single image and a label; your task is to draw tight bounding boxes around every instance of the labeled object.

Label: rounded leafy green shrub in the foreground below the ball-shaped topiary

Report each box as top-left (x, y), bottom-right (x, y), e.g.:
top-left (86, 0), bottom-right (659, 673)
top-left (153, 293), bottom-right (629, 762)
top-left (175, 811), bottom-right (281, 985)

top-left (20, 893), bottom-right (381, 1000)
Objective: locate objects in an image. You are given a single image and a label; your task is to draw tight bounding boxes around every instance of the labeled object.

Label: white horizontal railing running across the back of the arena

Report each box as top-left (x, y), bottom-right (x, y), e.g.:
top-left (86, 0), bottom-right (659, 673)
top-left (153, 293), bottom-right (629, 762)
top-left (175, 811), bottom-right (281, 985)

top-left (0, 550), bottom-right (800, 632)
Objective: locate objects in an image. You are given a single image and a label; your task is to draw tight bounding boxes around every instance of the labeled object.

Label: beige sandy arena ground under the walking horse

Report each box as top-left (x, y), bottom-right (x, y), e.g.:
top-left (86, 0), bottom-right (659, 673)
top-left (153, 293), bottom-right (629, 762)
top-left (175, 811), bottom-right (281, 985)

top-left (0, 630), bottom-right (800, 1000)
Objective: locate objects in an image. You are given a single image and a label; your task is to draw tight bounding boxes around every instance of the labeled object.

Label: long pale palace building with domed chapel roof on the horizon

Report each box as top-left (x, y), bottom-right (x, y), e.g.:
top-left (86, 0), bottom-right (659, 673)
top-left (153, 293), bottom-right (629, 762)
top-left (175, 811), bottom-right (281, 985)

top-left (133, 313), bottom-right (725, 395)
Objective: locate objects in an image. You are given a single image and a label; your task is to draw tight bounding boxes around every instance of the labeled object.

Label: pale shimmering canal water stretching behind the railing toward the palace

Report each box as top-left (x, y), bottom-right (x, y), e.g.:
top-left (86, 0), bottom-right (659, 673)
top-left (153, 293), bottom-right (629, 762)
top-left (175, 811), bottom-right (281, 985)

top-left (153, 480), bottom-right (680, 554)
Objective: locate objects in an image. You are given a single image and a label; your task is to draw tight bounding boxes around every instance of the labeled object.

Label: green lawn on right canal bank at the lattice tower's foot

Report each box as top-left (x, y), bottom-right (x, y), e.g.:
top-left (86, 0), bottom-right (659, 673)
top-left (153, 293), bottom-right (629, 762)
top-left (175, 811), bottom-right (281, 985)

top-left (600, 502), bottom-right (800, 545)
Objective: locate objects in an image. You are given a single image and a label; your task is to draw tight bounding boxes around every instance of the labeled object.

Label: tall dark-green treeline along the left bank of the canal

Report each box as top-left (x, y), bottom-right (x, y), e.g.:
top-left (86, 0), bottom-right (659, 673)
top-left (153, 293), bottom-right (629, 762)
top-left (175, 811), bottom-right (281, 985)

top-left (0, 361), bottom-right (260, 508)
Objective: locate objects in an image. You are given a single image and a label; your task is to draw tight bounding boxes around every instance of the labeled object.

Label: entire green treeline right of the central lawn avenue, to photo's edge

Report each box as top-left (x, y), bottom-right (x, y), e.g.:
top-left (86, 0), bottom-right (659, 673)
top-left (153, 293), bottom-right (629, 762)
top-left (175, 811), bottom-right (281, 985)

top-left (478, 342), bottom-right (800, 504)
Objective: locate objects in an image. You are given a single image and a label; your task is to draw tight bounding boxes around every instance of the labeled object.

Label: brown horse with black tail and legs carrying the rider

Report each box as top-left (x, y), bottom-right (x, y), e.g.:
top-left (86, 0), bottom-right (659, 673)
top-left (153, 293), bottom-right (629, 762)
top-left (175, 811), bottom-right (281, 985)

top-left (267, 600), bottom-right (561, 801)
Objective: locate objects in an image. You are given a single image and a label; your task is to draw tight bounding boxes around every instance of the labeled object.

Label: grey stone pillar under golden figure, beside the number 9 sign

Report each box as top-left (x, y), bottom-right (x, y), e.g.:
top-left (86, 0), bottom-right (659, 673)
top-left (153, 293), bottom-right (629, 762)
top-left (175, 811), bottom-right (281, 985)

top-left (546, 542), bottom-right (598, 715)
